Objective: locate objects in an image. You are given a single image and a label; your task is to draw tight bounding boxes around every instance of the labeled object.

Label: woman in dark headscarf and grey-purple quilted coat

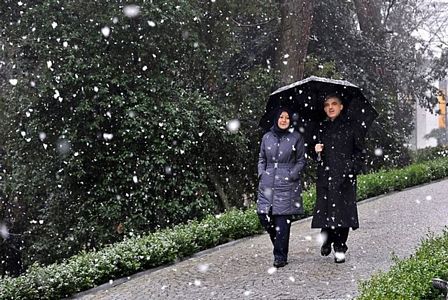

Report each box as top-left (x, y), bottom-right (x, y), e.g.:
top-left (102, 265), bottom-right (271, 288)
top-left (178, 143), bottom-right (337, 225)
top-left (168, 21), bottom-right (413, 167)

top-left (257, 108), bottom-right (305, 268)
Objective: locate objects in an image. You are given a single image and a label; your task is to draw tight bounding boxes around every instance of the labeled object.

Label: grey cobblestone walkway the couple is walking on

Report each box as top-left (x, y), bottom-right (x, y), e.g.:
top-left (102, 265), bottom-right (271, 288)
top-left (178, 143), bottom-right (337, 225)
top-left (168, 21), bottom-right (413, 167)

top-left (77, 180), bottom-right (448, 299)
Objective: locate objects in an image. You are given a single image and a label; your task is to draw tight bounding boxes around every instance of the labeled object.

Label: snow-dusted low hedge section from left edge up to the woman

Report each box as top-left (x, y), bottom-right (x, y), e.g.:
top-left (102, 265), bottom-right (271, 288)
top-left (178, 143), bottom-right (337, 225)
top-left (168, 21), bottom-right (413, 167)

top-left (0, 209), bottom-right (261, 299)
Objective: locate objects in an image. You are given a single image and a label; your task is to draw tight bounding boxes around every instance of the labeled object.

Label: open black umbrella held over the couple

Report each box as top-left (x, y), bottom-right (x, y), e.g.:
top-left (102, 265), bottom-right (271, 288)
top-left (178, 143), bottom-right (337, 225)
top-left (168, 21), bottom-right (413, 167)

top-left (259, 76), bottom-right (378, 148)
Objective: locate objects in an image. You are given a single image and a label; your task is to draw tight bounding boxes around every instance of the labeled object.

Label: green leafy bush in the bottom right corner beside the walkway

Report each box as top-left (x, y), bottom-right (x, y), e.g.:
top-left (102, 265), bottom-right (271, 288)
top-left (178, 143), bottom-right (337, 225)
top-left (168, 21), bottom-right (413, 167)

top-left (357, 230), bottom-right (448, 300)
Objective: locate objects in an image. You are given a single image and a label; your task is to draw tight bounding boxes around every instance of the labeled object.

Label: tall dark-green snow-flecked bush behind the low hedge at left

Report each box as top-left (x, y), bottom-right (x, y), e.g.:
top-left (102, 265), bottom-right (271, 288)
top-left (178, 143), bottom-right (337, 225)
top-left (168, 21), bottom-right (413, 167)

top-left (0, 0), bottom-right (260, 267)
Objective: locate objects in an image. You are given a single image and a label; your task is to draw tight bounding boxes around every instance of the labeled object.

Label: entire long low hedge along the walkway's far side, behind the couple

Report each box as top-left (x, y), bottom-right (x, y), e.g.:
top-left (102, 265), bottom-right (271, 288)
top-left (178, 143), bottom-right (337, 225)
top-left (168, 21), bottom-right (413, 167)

top-left (0, 158), bottom-right (448, 299)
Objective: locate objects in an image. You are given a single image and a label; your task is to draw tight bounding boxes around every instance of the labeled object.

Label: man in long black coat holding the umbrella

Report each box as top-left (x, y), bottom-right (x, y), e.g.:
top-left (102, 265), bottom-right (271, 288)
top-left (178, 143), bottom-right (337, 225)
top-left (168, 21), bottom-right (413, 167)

top-left (311, 95), bottom-right (364, 263)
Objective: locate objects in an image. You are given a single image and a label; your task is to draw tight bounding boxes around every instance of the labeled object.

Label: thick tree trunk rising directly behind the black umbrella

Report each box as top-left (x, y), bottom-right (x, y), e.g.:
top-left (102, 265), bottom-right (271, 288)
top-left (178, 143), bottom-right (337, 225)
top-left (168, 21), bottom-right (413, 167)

top-left (276, 0), bottom-right (313, 85)
